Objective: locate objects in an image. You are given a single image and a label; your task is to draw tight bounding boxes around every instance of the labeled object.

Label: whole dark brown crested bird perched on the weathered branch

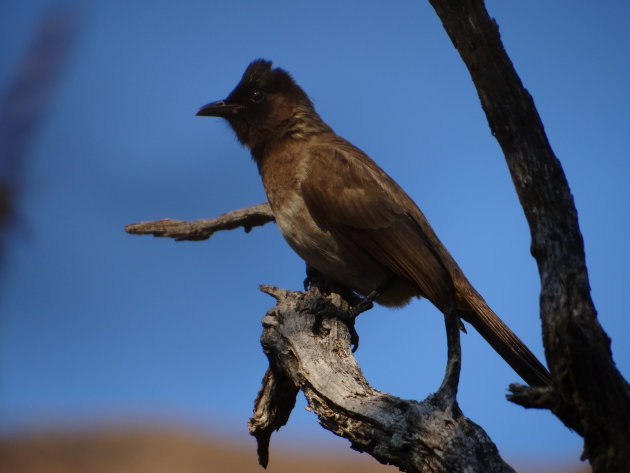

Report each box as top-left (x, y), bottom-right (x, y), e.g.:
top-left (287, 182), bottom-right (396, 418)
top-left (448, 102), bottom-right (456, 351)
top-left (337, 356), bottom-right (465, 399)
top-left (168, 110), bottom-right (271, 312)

top-left (197, 59), bottom-right (549, 386)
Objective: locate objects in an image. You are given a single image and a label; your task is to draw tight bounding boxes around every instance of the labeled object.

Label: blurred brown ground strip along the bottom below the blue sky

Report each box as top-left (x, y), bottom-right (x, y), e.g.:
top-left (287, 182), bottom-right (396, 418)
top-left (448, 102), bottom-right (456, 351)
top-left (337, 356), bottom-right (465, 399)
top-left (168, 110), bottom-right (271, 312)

top-left (0, 427), bottom-right (590, 473)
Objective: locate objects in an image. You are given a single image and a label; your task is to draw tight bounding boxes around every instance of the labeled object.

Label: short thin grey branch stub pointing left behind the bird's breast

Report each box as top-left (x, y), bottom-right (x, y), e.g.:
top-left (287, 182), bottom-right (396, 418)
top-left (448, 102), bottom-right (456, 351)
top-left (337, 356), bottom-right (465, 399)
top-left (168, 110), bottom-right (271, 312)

top-left (125, 202), bottom-right (275, 241)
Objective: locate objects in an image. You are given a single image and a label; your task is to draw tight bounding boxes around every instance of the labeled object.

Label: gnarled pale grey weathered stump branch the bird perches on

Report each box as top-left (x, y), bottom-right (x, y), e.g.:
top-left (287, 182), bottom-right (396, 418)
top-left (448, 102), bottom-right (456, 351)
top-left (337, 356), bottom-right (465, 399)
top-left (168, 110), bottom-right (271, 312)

top-left (250, 287), bottom-right (513, 473)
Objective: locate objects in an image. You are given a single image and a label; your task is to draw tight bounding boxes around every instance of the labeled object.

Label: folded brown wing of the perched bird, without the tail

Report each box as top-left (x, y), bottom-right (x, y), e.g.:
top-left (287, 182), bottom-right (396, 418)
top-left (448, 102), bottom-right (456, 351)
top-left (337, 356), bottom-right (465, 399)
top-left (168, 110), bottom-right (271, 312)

top-left (302, 143), bottom-right (454, 310)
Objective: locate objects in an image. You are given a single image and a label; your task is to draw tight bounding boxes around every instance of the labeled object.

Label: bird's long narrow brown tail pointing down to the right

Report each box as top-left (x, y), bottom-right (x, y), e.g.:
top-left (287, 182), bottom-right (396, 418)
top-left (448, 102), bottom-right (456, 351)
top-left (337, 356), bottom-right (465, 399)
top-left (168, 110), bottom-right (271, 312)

top-left (458, 283), bottom-right (551, 386)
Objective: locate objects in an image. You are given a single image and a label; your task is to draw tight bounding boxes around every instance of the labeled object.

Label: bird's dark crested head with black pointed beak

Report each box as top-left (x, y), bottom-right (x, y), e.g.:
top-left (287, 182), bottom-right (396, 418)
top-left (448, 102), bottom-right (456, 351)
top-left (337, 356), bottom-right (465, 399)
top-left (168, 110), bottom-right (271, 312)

top-left (197, 59), bottom-right (313, 150)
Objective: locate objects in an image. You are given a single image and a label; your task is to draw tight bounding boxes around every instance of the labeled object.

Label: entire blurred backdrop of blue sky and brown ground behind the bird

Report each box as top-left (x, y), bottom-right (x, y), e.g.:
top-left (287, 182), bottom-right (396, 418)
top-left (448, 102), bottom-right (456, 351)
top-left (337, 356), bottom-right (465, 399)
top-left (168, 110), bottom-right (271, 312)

top-left (0, 0), bottom-right (630, 472)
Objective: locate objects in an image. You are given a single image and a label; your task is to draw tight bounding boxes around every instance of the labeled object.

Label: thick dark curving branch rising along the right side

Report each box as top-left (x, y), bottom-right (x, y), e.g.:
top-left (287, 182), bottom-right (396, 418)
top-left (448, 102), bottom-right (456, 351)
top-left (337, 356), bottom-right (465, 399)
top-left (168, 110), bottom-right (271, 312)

top-left (430, 0), bottom-right (630, 466)
